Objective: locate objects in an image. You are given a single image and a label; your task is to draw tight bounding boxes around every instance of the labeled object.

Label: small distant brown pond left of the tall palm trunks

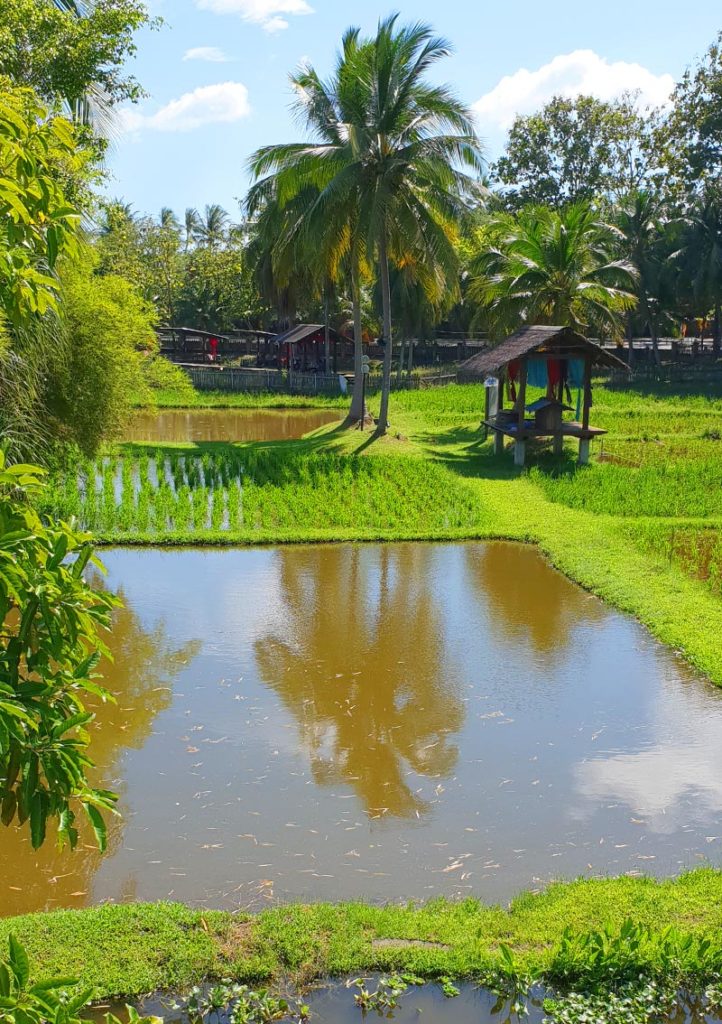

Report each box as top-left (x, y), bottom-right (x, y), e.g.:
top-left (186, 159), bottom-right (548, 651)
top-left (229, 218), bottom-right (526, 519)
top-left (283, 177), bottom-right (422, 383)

top-left (125, 409), bottom-right (341, 443)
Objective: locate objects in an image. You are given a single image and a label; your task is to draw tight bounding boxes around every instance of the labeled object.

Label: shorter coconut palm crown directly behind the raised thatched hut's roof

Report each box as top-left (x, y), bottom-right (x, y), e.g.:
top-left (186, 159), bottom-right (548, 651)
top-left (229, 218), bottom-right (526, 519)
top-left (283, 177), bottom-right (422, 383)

top-left (469, 203), bottom-right (637, 337)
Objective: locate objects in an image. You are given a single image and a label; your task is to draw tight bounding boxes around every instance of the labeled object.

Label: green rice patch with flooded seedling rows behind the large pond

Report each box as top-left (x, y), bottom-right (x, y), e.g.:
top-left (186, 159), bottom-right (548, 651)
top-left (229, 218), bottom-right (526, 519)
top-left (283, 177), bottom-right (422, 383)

top-left (52, 445), bottom-right (482, 541)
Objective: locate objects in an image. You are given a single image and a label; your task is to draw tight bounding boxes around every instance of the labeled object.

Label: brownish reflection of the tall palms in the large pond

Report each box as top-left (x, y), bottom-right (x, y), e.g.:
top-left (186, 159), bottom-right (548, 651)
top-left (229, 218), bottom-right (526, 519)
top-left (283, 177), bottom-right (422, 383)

top-left (255, 545), bottom-right (464, 818)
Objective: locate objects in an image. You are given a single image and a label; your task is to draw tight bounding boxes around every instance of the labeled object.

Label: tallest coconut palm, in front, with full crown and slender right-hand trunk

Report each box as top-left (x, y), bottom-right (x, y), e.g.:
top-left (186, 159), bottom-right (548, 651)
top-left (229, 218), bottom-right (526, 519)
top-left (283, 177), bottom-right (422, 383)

top-left (251, 15), bottom-right (481, 433)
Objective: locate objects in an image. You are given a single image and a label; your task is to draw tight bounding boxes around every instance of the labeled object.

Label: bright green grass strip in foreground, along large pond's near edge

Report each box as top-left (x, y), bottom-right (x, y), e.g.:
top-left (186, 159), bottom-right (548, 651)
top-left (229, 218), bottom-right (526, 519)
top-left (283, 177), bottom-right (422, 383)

top-left (0, 869), bottom-right (722, 998)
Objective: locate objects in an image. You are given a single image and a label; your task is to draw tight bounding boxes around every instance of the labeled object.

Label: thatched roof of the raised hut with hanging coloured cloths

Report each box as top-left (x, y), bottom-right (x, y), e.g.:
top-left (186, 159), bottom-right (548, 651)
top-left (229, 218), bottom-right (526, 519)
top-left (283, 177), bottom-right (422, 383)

top-left (459, 327), bottom-right (629, 381)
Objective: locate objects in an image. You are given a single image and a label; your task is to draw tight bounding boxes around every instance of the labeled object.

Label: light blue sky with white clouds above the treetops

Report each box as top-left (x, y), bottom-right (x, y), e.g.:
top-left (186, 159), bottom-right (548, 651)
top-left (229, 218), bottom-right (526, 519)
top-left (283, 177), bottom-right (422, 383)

top-left (108, 0), bottom-right (722, 214)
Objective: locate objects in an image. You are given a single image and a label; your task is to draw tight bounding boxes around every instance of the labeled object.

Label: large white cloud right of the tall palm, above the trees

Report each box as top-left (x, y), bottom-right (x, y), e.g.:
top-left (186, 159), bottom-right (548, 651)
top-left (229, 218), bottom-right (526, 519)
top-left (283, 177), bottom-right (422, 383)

top-left (473, 50), bottom-right (674, 130)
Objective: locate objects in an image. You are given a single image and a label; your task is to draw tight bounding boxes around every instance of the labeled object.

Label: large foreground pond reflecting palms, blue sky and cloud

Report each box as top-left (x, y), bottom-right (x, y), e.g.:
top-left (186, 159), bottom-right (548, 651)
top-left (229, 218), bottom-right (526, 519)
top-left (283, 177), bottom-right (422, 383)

top-left (0, 543), bottom-right (722, 914)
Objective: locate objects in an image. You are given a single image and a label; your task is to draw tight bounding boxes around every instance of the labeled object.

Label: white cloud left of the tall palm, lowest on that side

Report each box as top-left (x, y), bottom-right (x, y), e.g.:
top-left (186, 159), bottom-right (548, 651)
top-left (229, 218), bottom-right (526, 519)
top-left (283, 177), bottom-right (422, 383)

top-left (121, 82), bottom-right (251, 133)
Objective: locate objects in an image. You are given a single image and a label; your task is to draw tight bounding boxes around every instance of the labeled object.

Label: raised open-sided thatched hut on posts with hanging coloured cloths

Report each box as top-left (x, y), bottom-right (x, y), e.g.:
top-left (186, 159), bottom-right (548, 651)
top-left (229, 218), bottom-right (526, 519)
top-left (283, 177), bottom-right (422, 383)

top-left (458, 327), bottom-right (628, 466)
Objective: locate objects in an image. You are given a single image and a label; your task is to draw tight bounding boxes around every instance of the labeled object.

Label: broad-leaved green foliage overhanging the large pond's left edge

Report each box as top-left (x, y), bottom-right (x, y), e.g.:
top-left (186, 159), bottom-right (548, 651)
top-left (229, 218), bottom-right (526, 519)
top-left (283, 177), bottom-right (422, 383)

top-left (0, 456), bottom-right (116, 849)
